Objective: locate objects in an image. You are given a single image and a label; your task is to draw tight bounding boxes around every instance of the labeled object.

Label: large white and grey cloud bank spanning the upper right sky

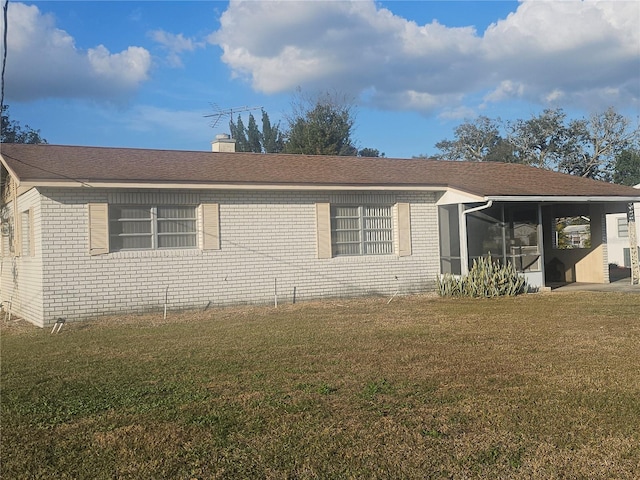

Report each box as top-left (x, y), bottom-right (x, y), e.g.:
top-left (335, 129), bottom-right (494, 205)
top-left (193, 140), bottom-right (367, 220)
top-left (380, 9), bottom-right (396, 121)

top-left (209, 0), bottom-right (640, 112)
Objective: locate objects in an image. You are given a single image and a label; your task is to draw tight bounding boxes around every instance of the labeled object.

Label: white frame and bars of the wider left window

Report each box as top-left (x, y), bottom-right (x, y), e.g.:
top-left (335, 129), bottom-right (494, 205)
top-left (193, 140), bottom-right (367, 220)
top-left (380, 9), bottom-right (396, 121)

top-left (109, 205), bottom-right (198, 252)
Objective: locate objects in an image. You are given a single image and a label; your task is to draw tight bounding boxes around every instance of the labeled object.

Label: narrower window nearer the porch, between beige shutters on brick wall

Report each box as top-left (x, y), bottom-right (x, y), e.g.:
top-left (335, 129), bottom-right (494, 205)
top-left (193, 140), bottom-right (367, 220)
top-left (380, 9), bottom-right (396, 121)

top-left (331, 205), bottom-right (393, 256)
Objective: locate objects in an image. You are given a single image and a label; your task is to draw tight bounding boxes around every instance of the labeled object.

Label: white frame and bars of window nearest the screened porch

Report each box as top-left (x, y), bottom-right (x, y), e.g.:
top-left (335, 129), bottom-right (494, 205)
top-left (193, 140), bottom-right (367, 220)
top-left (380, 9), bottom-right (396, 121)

top-left (331, 205), bottom-right (394, 257)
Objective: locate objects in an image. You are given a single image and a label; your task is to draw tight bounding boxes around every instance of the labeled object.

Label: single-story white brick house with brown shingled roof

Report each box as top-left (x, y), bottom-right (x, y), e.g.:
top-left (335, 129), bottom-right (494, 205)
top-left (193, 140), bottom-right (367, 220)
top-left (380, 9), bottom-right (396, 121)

top-left (0, 139), bottom-right (640, 326)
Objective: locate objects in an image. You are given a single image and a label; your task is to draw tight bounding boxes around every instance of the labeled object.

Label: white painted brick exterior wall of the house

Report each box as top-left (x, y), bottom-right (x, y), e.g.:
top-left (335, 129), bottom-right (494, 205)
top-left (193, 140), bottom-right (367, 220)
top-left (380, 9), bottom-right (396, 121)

top-left (1, 188), bottom-right (439, 326)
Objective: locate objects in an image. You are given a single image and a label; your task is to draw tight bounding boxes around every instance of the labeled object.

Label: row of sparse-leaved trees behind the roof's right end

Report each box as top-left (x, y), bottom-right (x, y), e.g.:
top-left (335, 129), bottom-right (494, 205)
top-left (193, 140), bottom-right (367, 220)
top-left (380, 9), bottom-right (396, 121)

top-left (436, 108), bottom-right (639, 180)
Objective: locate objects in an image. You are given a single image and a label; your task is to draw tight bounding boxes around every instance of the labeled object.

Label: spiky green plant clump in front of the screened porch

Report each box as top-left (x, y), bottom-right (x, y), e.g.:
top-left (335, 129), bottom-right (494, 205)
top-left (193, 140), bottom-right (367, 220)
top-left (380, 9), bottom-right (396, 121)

top-left (437, 256), bottom-right (528, 298)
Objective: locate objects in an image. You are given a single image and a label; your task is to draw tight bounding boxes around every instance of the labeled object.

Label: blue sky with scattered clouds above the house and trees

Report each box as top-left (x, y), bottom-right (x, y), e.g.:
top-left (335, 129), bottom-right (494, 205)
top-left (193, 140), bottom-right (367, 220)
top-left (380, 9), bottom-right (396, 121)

top-left (3, 0), bottom-right (640, 158)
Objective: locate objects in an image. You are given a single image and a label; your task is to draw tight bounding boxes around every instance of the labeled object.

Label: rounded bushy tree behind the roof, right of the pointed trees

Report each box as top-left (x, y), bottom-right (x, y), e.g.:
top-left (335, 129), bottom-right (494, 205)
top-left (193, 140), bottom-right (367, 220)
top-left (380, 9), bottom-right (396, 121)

top-left (285, 93), bottom-right (358, 155)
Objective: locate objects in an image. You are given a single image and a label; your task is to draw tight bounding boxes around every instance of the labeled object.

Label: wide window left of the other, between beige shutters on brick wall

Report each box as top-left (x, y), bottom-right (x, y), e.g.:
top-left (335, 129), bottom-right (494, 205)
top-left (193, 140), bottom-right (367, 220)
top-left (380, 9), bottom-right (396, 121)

top-left (109, 205), bottom-right (197, 251)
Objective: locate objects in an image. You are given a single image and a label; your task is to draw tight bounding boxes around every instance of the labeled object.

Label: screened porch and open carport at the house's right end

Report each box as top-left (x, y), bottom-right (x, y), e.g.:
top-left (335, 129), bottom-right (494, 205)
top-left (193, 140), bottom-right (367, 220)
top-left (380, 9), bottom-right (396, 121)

top-left (438, 200), bottom-right (623, 287)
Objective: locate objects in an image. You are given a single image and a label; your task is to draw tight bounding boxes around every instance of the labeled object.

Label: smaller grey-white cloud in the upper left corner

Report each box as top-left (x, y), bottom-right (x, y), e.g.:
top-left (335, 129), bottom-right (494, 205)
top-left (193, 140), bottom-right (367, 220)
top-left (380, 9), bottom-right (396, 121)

top-left (0, 3), bottom-right (151, 101)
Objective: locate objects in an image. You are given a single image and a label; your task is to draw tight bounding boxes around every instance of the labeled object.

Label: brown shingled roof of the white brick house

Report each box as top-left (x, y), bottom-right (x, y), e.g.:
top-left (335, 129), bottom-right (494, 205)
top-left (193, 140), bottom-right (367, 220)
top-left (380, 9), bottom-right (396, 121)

top-left (0, 144), bottom-right (640, 201)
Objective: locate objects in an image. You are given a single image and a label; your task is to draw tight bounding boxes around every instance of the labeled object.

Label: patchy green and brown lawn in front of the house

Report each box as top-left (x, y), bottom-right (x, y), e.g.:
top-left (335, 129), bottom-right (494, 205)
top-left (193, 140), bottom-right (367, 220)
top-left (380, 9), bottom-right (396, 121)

top-left (0, 293), bottom-right (640, 479)
